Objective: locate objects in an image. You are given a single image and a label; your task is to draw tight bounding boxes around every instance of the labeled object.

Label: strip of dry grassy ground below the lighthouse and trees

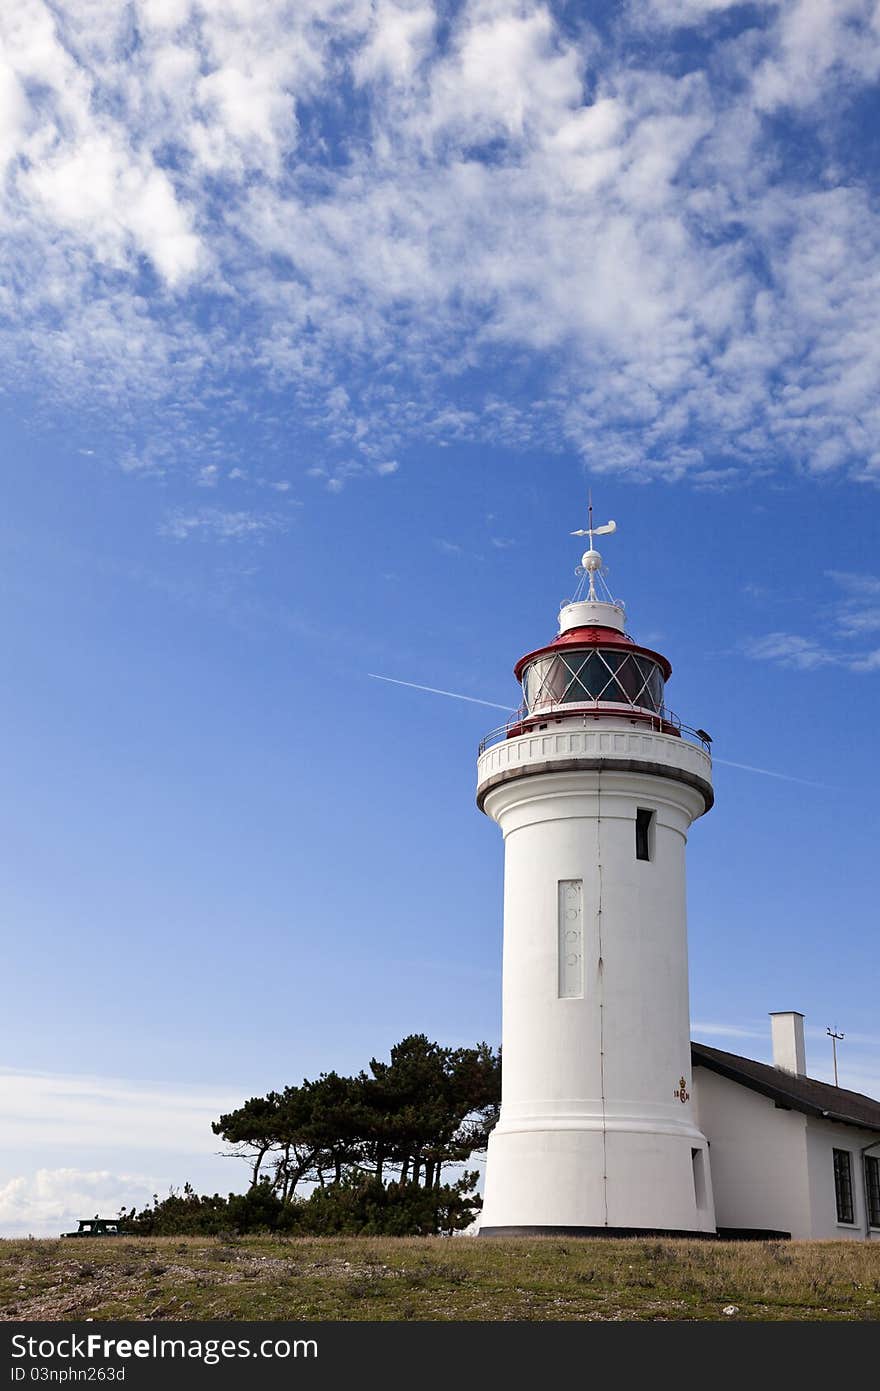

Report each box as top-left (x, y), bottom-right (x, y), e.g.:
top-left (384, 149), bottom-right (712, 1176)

top-left (0, 1237), bottom-right (880, 1320)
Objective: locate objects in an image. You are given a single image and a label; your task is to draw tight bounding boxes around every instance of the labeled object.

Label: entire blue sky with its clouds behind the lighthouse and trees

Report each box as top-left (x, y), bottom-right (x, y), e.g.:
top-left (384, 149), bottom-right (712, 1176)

top-left (0, 0), bottom-right (880, 1232)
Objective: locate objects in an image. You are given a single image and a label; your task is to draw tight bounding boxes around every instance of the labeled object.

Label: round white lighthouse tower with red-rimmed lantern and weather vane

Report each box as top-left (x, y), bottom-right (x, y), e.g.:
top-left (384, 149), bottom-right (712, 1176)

top-left (477, 508), bottom-right (715, 1235)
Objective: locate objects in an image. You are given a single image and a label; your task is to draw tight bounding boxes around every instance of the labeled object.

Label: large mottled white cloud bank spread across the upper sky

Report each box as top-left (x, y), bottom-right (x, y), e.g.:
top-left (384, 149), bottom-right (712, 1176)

top-left (0, 0), bottom-right (880, 489)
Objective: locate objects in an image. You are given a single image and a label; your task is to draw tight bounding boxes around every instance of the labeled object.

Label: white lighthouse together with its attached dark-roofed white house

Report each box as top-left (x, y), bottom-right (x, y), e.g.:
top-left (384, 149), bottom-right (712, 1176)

top-left (477, 515), bottom-right (880, 1237)
